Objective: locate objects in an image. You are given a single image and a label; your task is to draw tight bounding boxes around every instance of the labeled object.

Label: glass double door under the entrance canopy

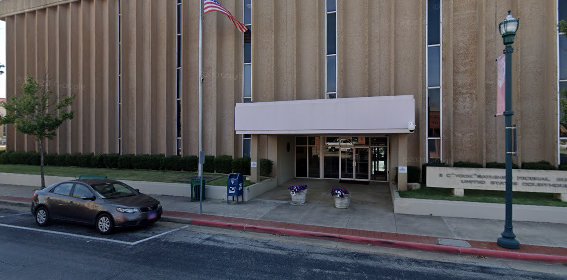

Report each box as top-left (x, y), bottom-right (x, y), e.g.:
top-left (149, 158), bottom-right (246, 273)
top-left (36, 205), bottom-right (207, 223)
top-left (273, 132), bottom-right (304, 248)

top-left (340, 147), bottom-right (370, 180)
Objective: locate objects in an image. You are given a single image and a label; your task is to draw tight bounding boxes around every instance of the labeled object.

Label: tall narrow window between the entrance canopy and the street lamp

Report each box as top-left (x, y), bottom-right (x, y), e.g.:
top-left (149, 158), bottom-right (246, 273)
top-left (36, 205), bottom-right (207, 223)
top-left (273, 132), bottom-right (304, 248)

top-left (426, 0), bottom-right (443, 163)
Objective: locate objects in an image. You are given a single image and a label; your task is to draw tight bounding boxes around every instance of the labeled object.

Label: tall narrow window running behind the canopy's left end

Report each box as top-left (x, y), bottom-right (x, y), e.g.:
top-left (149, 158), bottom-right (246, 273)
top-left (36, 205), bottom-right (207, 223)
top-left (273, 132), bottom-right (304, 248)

top-left (242, 0), bottom-right (252, 157)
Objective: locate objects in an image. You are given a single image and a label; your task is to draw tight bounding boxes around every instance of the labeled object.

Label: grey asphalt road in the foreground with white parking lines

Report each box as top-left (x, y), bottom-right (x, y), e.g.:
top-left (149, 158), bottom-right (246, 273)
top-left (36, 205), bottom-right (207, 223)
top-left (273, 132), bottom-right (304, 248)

top-left (0, 209), bottom-right (567, 280)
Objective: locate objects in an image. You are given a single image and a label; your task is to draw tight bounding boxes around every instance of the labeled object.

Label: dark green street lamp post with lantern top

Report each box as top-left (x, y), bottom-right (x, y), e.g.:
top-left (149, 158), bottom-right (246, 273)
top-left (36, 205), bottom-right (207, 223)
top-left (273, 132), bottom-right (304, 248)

top-left (497, 11), bottom-right (520, 249)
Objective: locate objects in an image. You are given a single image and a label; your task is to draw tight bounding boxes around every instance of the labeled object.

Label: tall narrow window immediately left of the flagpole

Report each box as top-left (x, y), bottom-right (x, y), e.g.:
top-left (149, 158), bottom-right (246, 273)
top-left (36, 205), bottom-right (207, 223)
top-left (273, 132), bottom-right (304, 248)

top-left (175, 0), bottom-right (183, 156)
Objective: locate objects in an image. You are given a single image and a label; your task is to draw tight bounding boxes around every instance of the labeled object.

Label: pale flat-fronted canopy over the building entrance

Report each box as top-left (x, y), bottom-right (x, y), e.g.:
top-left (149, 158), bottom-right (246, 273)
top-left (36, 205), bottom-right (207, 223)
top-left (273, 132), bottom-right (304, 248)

top-left (235, 95), bottom-right (415, 134)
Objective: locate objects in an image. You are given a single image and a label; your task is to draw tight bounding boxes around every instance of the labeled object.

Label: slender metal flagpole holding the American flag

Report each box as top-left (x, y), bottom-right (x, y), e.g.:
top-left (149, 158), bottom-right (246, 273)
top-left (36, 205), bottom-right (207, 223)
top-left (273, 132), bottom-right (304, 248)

top-left (199, 0), bottom-right (205, 214)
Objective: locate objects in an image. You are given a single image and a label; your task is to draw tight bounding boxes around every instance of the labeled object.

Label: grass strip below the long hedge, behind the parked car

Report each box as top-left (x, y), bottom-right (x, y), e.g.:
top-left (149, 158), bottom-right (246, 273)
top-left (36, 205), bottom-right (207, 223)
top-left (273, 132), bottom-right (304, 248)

top-left (0, 164), bottom-right (240, 186)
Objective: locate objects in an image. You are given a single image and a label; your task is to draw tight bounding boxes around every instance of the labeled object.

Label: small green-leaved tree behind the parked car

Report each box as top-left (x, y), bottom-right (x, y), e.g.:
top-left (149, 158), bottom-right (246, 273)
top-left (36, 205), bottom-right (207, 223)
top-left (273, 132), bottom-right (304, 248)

top-left (0, 77), bottom-right (73, 188)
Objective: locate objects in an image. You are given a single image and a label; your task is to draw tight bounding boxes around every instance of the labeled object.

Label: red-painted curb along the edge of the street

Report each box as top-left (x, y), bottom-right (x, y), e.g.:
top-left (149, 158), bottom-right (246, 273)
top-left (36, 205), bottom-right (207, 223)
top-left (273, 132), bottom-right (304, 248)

top-left (162, 215), bottom-right (567, 263)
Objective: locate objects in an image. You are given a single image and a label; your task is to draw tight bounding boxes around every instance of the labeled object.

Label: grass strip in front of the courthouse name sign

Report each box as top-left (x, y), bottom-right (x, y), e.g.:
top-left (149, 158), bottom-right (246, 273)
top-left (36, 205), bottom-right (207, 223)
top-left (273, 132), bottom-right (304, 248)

top-left (399, 187), bottom-right (567, 207)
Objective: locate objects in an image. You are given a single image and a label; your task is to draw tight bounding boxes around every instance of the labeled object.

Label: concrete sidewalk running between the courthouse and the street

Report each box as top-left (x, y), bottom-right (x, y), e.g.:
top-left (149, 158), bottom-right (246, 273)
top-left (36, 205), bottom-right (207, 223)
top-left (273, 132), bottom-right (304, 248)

top-left (0, 185), bottom-right (567, 263)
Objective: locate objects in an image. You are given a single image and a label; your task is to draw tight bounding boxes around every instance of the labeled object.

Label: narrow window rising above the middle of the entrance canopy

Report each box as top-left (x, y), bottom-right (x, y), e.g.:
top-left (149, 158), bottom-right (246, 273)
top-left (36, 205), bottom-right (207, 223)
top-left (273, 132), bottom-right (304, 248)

top-left (325, 0), bottom-right (338, 99)
